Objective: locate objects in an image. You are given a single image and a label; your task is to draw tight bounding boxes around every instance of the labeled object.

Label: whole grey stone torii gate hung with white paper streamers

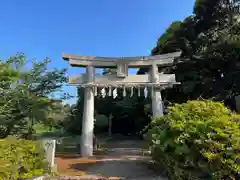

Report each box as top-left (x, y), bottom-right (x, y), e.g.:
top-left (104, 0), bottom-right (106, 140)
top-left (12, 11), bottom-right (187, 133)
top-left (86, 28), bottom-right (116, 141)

top-left (62, 52), bottom-right (181, 156)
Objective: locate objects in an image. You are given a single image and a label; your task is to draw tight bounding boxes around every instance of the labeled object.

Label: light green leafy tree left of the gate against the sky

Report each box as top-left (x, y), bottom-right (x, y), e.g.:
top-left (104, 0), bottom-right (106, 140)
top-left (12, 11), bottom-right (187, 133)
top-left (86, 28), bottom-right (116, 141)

top-left (0, 54), bottom-right (66, 137)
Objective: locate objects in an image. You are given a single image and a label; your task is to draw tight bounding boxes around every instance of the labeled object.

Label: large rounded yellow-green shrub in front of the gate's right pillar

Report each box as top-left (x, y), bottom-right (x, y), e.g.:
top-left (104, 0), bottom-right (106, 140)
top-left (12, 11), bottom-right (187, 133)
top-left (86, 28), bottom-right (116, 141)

top-left (146, 101), bottom-right (240, 180)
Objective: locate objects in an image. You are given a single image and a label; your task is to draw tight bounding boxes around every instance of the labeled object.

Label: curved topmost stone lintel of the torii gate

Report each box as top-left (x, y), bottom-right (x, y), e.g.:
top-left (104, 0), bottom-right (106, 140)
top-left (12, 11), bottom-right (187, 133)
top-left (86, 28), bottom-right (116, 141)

top-left (62, 52), bottom-right (181, 68)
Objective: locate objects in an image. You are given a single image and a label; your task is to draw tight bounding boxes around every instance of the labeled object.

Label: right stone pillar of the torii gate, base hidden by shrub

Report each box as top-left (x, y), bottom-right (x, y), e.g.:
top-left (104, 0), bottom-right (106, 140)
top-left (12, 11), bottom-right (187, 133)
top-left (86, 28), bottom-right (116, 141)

top-left (151, 64), bottom-right (163, 117)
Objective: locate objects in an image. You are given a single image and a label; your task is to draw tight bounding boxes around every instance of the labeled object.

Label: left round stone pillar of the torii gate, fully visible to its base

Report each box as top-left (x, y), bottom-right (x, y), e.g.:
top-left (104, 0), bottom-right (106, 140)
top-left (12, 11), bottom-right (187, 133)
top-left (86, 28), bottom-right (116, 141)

top-left (81, 66), bottom-right (95, 156)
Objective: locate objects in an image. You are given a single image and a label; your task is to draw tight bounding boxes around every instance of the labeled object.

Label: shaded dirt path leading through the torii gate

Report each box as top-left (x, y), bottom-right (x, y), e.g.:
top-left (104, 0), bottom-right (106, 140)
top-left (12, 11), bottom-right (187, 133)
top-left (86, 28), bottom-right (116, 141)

top-left (56, 140), bottom-right (167, 180)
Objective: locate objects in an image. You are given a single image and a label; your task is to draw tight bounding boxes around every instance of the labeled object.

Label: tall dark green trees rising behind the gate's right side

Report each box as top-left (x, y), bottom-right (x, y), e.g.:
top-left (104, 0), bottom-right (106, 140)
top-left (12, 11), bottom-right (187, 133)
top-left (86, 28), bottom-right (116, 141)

top-left (140, 0), bottom-right (240, 108)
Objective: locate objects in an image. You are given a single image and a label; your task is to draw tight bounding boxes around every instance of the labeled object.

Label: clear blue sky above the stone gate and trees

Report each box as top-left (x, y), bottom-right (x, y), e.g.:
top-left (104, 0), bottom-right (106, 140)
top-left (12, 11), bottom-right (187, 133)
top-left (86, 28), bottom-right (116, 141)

top-left (0, 0), bottom-right (194, 103)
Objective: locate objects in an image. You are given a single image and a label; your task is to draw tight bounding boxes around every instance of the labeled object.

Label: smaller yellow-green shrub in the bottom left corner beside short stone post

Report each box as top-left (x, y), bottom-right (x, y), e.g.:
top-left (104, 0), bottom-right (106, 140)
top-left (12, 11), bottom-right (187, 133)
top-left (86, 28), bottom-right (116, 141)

top-left (0, 136), bottom-right (48, 180)
